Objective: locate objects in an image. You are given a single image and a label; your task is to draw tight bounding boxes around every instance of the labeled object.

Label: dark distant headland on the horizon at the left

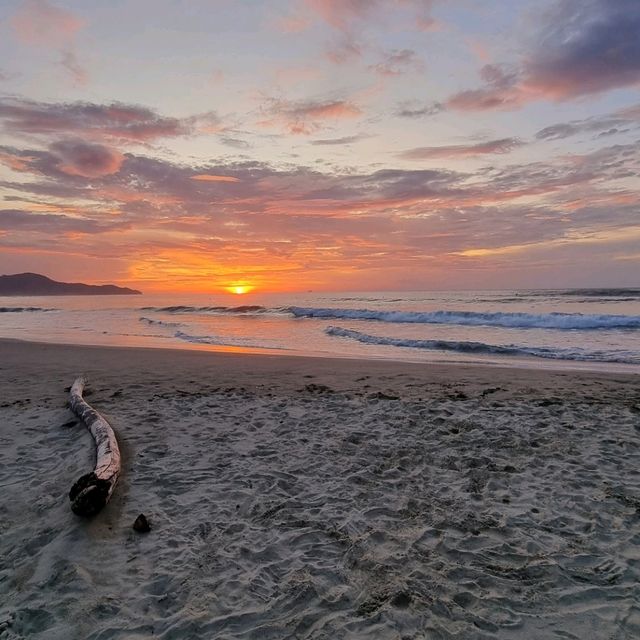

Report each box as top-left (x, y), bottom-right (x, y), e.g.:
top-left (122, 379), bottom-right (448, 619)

top-left (0, 273), bottom-right (142, 296)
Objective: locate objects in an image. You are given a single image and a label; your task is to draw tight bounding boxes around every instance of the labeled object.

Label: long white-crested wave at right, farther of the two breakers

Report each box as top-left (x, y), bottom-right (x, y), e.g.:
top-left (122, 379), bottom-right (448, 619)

top-left (289, 307), bottom-right (640, 329)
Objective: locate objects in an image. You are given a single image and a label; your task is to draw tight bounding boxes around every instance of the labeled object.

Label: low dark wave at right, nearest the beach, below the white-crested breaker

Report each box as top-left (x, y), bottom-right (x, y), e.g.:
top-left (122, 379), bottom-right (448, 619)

top-left (325, 327), bottom-right (640, 364)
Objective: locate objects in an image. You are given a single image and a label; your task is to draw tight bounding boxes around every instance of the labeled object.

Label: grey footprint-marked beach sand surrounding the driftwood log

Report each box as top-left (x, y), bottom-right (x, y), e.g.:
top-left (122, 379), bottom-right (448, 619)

top-left (0, 341), bottom-right (640, 640)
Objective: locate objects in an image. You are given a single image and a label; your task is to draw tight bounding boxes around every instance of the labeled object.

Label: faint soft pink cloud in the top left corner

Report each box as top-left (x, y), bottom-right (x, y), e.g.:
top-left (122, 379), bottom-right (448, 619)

top-left (9, 0), bottom-right (84, 47)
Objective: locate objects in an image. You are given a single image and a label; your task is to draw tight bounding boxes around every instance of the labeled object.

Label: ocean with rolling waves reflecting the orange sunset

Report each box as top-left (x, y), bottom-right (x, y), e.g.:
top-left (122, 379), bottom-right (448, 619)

top-left (0, 289), bottom-right (640, 372)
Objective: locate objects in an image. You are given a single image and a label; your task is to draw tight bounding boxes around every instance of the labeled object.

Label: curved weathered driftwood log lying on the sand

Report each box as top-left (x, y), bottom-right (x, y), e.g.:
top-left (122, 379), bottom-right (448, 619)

top-left (69, 376), bottom-right (120, 516)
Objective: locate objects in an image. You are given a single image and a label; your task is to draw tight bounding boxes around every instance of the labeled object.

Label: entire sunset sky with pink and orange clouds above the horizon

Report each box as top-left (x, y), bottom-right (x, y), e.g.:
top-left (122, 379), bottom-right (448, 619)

top-left (0, 0), bottom-right (640, 293)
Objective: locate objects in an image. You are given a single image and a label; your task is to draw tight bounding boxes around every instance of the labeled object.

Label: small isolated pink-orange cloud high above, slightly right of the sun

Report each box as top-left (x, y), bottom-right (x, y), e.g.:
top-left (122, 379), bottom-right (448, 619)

top-left (262, 100), bottom-right (362, 135)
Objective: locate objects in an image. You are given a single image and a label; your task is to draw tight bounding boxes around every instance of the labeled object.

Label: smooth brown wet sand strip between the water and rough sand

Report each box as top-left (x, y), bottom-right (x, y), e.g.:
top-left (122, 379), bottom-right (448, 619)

top-left (0, 338), bottom-right (640, 389)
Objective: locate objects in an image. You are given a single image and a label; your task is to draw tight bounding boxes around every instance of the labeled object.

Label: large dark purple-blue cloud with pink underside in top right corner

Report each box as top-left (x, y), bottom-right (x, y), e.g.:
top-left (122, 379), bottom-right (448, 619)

top-left (446, 0), bottom-right (640, 111)
